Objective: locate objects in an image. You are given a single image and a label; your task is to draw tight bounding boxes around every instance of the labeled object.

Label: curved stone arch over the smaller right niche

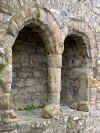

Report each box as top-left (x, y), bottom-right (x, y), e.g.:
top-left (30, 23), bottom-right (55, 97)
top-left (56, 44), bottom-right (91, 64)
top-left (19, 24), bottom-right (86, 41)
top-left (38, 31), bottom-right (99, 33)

top-left (65, 19), bottom-right (97, 67)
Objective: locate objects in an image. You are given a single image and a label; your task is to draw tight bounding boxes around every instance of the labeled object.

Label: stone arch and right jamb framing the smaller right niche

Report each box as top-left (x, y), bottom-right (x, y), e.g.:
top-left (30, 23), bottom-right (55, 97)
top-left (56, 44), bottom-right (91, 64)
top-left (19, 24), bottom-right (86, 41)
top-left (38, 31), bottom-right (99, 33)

top-left (61, 18), bottom-right (99, 111)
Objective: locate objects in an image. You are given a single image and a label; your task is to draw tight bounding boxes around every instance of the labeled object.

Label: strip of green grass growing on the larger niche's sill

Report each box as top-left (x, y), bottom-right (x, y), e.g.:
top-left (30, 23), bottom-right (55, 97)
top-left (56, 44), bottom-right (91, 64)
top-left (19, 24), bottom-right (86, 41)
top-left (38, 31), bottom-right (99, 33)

top-left (18, 104), bottom-right (45, 111)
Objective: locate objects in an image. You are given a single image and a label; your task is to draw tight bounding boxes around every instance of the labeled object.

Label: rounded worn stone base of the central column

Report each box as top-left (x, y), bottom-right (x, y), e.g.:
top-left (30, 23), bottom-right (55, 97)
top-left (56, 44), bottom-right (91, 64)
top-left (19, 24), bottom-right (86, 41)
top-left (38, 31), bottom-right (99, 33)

top-left (43, 104), bottom-right (63, 118)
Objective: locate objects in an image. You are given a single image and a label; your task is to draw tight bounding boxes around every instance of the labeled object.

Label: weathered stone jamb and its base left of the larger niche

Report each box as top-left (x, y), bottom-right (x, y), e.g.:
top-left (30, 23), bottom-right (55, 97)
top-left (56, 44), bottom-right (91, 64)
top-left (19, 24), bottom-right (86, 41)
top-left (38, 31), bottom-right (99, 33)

top-left (0, 48), bottom-right (16, 130)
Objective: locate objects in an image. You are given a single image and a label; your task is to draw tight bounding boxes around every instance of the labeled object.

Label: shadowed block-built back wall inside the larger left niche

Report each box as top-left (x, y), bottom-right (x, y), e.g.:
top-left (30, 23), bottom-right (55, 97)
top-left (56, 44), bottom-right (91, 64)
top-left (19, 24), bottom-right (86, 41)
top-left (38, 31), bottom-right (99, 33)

top-left (12, 26), bottom-right (47, 108)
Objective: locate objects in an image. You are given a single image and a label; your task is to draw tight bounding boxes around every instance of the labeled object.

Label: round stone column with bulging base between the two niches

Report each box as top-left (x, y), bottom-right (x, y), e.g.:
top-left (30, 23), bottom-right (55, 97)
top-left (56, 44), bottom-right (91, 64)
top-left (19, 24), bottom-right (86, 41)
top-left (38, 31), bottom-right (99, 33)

top-left (44, 55), bottom-right (63, 118)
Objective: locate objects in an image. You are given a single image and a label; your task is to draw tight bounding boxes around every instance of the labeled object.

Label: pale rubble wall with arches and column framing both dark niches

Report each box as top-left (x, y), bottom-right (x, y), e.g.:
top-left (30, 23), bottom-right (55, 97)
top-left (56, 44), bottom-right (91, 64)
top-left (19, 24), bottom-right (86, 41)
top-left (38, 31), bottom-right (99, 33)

top-left (0, 0), bottom-right (100, 132)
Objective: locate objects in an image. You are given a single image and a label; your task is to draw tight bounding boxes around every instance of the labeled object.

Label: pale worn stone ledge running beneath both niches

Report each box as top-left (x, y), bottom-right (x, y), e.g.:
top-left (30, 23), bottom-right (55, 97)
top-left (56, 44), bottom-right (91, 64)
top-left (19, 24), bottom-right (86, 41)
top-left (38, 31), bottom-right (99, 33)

top-left (0, 106), bottom-right (100, 133)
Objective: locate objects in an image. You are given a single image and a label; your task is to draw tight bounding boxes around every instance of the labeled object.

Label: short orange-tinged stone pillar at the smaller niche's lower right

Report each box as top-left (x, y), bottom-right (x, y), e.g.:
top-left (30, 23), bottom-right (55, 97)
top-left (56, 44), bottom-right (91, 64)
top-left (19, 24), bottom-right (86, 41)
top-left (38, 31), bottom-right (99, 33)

top-left (78, 76), bottom-right (98, 111)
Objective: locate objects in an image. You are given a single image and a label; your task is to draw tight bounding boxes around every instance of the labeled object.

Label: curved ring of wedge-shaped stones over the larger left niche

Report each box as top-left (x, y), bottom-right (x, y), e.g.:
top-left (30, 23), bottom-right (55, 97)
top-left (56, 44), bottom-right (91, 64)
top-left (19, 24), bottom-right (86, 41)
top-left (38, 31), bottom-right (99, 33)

top-left (7, 7), bottom-right (64, 54)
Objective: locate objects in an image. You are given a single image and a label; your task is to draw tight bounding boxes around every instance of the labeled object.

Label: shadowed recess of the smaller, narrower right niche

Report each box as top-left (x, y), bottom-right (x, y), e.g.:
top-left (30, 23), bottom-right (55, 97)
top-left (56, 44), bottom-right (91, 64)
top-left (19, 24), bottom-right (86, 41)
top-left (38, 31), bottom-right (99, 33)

top-left (61, 34), bottom-right (90, 109)
